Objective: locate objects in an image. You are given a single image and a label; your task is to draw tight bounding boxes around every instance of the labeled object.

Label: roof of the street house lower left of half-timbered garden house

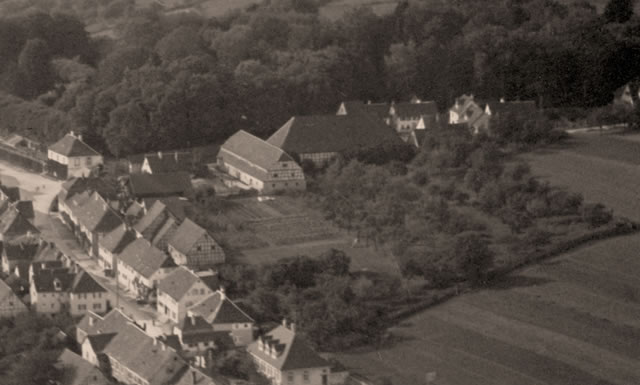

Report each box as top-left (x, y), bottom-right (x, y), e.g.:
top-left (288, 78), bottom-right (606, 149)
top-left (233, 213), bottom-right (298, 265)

top-left (119, 238), bottom-right (175, 278)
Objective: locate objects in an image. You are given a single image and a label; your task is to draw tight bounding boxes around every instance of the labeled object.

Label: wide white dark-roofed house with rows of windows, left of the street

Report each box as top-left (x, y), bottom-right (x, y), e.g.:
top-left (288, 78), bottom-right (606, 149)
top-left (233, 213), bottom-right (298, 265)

top-left (30, 263), bottom-right (109, 316)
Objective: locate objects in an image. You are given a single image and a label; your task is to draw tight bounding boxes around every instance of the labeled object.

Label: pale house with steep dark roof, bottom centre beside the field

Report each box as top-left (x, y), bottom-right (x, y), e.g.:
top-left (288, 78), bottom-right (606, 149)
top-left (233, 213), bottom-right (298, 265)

top-left (247, 321), bottom-right (331, 385)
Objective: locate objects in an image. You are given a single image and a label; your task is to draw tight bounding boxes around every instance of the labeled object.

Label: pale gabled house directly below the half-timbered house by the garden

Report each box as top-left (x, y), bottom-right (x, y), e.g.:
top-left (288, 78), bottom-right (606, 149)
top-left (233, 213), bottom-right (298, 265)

top-left (157, 266), bottom-right (218, 323)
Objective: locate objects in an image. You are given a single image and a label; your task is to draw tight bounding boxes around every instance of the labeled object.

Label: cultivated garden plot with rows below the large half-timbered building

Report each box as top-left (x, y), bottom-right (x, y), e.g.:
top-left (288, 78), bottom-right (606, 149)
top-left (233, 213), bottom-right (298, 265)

top-left (212, 196), bottom-right (399, 274)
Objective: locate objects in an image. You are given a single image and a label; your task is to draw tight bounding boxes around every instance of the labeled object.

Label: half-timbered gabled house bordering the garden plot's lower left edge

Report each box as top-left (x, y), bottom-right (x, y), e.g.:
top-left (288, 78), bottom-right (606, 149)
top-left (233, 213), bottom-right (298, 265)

top-left (167, 218), bottom-right (225, 268)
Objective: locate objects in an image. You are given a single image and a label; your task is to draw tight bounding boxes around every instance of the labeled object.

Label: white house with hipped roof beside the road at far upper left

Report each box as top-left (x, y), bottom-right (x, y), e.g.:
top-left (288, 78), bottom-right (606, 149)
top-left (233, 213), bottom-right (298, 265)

top-left (47, 131), bottom-right (104, 179)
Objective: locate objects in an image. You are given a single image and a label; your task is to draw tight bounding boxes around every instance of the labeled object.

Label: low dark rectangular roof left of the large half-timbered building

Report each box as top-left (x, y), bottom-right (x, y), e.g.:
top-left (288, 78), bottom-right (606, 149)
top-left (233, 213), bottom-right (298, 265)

top-left (129, 171), bottom-right (193, 198)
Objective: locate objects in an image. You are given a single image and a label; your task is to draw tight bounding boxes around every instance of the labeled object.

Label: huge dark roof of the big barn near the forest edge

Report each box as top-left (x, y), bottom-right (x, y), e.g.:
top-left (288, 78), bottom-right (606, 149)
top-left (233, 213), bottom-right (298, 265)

top-left (267, 114), bottom-right (402, 154)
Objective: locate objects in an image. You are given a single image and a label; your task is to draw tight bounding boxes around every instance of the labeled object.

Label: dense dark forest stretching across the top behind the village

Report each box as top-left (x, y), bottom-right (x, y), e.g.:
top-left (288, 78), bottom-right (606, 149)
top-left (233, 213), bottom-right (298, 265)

top-left (0, 0), bottom-right (640, 157)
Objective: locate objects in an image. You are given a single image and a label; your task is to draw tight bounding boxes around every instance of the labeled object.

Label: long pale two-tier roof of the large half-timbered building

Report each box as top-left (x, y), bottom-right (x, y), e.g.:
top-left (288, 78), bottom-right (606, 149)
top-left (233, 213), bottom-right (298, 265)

top-left (218, 130), bottom-right (293, 181)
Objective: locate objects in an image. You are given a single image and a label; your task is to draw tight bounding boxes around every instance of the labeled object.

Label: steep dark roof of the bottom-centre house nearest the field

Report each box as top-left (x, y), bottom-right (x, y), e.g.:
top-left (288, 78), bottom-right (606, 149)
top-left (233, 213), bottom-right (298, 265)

top-left (248, 325), bottom-right (331, 370)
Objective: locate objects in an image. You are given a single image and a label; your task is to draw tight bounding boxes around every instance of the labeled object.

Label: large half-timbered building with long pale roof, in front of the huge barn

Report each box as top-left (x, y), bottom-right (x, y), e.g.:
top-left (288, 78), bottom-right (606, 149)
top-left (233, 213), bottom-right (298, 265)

top-left (218, 130), bottom-right (306, 194)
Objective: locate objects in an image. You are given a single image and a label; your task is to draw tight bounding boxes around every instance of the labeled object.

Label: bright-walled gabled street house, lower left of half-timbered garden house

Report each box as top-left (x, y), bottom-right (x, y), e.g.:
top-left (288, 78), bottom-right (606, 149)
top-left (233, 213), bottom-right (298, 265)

top-left (117, 238), bottom-right (176, 298)
